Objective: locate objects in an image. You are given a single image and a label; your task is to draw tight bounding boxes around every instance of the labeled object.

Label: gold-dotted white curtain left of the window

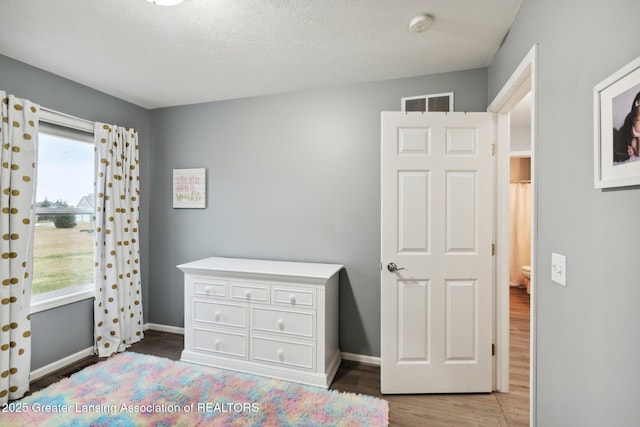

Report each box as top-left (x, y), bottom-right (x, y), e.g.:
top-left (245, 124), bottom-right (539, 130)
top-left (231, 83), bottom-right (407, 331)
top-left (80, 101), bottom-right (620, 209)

top-left (0, 91), bottom-right (39, 406)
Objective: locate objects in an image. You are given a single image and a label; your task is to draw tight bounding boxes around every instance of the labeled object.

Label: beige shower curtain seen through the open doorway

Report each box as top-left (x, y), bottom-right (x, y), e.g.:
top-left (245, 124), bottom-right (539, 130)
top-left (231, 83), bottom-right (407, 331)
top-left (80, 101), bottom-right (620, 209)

top-left (509, 183), bottom-right (531, 286)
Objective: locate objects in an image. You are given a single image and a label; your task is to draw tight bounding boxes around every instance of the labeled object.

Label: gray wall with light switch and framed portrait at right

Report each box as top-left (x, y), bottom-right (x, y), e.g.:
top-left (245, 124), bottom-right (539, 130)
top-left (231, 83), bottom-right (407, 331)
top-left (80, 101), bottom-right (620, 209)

top-left (489, 0), bottom-right (640, 426)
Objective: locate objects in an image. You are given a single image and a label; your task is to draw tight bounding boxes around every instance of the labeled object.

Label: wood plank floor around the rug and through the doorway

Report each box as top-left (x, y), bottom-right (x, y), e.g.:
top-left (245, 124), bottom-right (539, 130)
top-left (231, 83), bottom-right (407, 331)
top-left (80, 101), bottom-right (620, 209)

top-left (31, 288), bottom-right (529, 427)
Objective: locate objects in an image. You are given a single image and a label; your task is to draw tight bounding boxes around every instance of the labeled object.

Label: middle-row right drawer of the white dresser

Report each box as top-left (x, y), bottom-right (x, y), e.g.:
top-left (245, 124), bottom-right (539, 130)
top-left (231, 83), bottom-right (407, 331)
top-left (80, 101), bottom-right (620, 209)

top-left (251, 306), bottom-right (315, 338)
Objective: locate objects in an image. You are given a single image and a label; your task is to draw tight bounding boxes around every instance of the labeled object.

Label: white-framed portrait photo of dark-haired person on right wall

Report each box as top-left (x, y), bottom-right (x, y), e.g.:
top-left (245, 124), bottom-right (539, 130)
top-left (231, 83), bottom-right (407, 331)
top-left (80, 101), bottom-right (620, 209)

top-left (593, 58), bottom-right (640, 188)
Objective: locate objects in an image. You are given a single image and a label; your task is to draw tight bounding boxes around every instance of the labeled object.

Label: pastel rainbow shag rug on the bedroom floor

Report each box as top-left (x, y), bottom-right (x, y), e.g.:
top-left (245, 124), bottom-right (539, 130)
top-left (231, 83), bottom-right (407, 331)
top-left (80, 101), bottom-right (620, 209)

top-left (0, 352), bottom-right (389, 427)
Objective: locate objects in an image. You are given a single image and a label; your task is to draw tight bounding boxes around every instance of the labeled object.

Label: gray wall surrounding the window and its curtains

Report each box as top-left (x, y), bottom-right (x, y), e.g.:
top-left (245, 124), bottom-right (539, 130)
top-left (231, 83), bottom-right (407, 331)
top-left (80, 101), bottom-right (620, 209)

top-left (0, 55), bottom-right (150, 370)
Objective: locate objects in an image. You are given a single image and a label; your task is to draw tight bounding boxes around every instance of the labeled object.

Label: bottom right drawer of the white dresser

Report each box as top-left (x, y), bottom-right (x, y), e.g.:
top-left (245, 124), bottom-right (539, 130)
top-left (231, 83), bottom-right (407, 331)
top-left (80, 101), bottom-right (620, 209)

top-left (251, 336), bottom-right (315, 370)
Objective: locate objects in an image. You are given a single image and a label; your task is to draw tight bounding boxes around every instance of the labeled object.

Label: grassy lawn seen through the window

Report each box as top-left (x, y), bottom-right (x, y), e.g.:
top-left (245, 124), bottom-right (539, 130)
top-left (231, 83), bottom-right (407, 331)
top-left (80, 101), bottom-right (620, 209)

top-left (32, 223), bottom-right (94, 294)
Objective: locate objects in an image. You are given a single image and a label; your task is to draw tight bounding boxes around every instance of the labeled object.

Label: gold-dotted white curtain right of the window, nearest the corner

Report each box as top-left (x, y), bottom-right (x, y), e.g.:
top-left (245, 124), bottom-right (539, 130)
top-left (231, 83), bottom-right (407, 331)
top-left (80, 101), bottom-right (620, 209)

top-left (94, 123), bottom-right (143, 357)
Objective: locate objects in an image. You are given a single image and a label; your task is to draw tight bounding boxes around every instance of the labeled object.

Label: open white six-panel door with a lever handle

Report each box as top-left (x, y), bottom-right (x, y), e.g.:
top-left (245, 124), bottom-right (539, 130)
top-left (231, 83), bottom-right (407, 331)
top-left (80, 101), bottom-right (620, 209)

top-left (381, 112), bottom-right (494, 393)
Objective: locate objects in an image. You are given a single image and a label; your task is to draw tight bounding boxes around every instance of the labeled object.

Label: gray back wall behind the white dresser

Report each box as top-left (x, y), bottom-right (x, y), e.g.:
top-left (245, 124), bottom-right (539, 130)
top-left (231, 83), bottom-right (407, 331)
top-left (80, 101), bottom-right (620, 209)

top-left (149, 69), bottom-right (487, 356)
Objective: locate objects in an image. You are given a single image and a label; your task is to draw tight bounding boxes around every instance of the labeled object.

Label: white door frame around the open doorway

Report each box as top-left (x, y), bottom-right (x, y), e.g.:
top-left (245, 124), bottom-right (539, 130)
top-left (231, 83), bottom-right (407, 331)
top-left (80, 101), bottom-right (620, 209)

top-left (487, 44), bottom-right (538, 426)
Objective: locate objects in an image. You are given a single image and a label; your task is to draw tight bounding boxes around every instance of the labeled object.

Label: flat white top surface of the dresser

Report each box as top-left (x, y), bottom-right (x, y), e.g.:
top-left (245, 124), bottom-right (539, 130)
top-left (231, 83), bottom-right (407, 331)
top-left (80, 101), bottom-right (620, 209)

top-left (178, 257), bottom-right (343, 279)
